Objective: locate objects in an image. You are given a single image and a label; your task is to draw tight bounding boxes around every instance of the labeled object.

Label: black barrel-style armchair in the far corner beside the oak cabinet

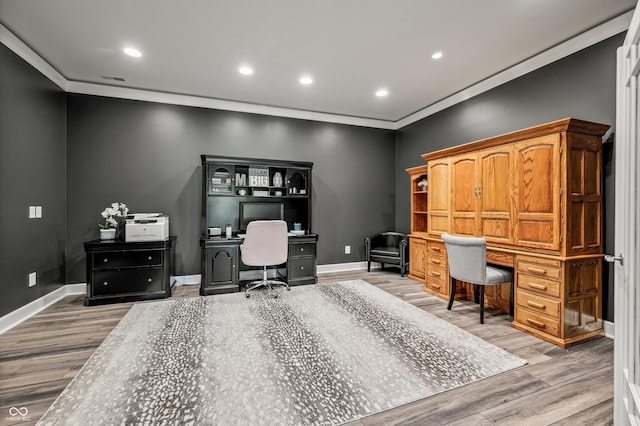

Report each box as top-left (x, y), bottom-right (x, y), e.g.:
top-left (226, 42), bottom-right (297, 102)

top-left (364, 232), bottom-right (409, 277)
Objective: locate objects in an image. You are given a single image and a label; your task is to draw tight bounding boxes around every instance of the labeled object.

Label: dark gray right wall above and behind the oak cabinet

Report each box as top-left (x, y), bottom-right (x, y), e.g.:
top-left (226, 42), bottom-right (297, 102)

top-left (395, 34), bottom-right (624, 321)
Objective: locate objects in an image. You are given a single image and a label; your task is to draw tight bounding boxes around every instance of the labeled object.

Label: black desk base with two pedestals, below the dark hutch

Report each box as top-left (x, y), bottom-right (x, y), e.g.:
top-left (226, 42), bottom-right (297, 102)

top-left (200, 234), bottom-right (318, 296)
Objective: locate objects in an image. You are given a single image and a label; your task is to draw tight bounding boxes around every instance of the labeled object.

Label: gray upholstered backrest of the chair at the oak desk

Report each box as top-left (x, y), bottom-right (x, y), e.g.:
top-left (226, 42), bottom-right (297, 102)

top-left (441, 234), bottom-right (487, 284)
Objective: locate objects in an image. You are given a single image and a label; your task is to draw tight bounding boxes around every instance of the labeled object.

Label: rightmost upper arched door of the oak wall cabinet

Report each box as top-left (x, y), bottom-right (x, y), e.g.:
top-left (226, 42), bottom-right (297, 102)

top-left (514, 134), bottom-right (560, 250)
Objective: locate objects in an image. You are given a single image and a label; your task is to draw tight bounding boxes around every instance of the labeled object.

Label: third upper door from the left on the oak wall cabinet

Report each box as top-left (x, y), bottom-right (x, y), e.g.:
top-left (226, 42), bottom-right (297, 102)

top-left (478, 146), bottom-right (513, 244)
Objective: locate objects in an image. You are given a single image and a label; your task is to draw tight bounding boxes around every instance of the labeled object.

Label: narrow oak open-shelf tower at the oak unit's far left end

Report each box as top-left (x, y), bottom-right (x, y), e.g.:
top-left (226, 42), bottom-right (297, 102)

top-left (406, 166), bottom-right (428, 281)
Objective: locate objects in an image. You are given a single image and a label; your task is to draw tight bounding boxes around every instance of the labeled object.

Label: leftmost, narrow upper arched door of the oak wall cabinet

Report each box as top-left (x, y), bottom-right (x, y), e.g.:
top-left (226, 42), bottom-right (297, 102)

top-left (427, 159), bottom-right (450, 236)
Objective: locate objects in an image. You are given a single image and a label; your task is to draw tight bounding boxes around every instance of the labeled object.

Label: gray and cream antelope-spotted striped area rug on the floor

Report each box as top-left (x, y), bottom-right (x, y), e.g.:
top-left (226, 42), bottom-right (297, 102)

top-left (39, 280), bottom-right (526, 425)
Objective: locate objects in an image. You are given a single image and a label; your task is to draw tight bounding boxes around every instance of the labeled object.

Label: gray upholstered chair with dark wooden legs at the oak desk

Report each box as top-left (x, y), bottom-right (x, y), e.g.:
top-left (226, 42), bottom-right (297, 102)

top-left (442, 234), bottom-right (513, 324)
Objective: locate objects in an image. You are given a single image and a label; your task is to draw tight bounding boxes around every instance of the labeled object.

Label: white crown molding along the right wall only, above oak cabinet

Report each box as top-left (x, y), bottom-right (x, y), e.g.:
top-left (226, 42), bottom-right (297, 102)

top-left (395, 10), bottom-right (633, 129)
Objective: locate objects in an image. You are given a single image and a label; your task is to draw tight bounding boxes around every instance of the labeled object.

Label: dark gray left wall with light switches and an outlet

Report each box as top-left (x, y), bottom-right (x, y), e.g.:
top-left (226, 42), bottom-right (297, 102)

top-left (0, 44), bottom-right (65, 316)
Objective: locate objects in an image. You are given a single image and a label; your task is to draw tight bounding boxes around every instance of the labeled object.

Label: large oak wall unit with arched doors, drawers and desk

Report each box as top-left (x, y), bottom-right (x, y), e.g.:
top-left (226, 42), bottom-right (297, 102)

top-left (407, 118), bottom-right (609, 347)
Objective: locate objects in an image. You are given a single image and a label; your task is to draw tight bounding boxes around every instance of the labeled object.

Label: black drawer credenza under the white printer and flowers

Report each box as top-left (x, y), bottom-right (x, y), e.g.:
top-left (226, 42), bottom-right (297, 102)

top-left (84, 236), bottom-right (176, 306)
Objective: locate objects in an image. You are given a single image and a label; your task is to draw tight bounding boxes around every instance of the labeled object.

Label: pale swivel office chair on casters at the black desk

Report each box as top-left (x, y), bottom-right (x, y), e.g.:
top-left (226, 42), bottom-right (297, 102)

top-left (240, 220), bottom-right (291, 297)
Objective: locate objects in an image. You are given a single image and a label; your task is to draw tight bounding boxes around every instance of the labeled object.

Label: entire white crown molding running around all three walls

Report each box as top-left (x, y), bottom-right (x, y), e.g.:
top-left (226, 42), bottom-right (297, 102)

top-left (0, 10), bottom-right (633, 130)
